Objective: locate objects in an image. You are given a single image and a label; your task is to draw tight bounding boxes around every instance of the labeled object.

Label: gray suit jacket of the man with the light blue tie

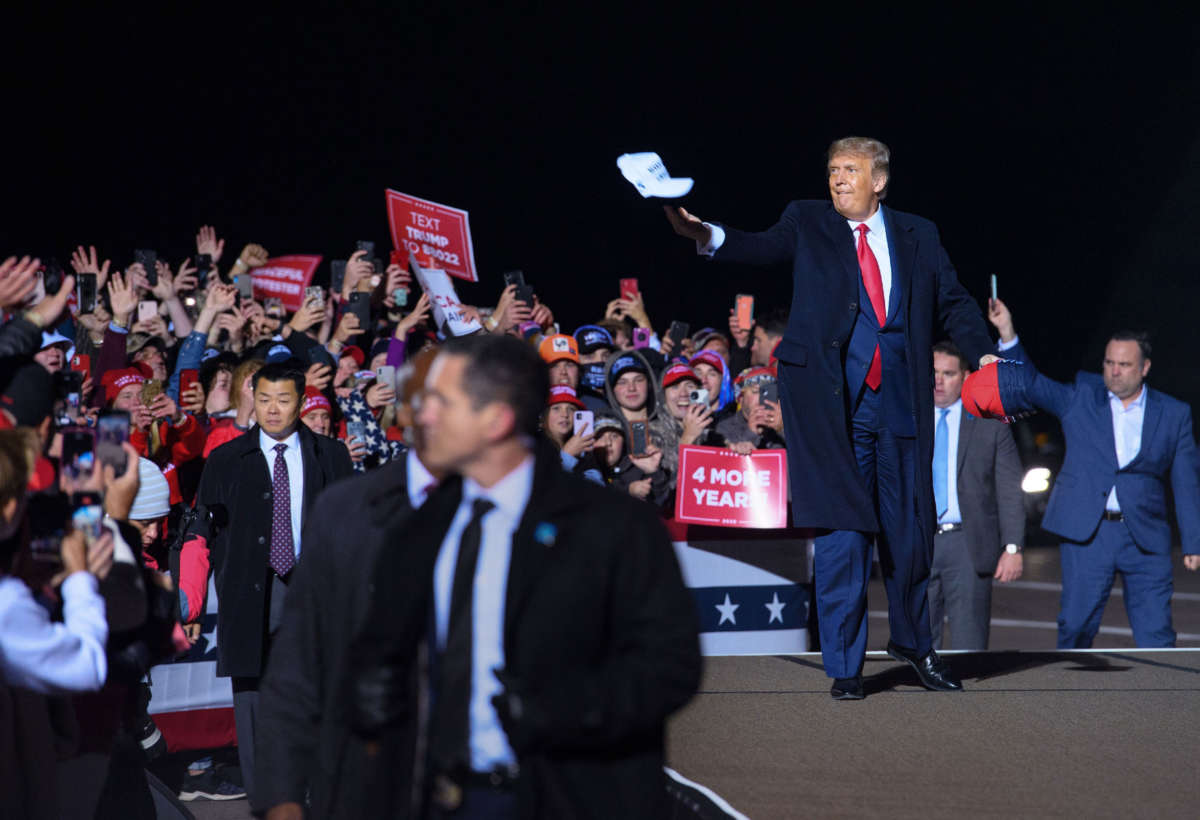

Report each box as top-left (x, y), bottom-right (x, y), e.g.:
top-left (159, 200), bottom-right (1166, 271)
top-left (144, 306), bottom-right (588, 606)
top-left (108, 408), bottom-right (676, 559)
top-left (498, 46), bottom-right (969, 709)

top-left (958, 411), bottom-right (1025, 575)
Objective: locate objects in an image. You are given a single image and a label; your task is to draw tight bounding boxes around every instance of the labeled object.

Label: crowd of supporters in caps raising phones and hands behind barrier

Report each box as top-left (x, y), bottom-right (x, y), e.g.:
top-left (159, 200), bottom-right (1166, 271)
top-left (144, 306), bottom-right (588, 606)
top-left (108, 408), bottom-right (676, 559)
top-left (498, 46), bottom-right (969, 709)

top-left (0, 227), bottom-right (786, 816)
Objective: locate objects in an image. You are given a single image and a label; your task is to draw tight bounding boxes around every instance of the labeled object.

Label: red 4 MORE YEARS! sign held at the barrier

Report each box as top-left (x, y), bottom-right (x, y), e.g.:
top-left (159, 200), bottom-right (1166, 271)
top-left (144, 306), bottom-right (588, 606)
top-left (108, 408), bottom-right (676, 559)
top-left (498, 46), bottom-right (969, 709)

top-left (676, 444), bottom-right (787, 529)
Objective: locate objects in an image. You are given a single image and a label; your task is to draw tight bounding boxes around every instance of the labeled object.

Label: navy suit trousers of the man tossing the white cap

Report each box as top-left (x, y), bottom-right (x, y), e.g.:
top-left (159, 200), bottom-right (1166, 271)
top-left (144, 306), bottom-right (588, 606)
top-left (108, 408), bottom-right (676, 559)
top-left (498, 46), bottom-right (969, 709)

top-left (812, 388), bottom-right (932, 677)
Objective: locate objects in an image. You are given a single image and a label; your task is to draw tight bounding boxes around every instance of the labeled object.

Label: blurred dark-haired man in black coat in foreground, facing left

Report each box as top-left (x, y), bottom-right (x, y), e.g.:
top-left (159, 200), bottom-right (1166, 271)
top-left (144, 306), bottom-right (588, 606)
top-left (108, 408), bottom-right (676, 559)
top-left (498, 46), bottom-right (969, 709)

top-left (348, 336), bottom-right (701, 818)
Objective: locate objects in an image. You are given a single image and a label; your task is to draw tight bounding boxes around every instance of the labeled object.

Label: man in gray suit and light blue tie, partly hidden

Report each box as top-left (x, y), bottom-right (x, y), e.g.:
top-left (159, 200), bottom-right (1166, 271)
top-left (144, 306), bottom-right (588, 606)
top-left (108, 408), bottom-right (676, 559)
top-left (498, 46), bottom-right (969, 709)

top-left (926, 342), bottom-right (1025, 650)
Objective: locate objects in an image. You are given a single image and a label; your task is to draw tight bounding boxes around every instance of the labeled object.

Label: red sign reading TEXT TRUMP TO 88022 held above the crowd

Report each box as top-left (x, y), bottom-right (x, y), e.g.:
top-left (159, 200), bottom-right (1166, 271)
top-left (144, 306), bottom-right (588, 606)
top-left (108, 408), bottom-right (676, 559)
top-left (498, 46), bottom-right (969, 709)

top-left (388, 188), bottom-right (479, 282)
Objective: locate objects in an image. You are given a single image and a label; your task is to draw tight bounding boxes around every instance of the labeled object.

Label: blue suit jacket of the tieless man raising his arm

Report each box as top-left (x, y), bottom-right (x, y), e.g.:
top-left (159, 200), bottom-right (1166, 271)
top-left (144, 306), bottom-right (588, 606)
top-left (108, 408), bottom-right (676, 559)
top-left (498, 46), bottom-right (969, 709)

top-left (1012, 355), bottom-right (1200, 555)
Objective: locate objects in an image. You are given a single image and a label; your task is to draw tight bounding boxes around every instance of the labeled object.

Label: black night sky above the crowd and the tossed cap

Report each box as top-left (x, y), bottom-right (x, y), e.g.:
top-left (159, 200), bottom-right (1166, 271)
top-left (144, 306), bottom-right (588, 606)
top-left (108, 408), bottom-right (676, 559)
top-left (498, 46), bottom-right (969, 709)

top-left (7, 4), bottom-right (1200, 401)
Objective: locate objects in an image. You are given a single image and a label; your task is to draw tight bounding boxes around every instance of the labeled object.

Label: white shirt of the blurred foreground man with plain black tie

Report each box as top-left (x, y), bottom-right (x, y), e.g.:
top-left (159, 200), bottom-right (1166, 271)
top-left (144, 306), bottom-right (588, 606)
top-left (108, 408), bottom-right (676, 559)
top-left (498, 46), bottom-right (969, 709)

top-left (433, 456), bottom-right (533, 772)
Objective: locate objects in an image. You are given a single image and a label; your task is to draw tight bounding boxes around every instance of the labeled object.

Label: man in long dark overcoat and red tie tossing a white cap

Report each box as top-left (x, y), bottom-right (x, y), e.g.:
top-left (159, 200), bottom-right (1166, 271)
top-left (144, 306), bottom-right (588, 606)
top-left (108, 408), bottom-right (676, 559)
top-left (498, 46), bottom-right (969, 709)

top-left (666, 137), bottom-right (995, 700)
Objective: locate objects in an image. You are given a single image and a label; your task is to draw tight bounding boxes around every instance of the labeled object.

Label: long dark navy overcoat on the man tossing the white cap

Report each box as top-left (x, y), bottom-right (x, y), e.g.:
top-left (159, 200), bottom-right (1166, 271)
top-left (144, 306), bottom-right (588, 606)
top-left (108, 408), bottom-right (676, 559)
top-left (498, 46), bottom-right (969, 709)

top-left (714, 200), bottom-right (994, 533)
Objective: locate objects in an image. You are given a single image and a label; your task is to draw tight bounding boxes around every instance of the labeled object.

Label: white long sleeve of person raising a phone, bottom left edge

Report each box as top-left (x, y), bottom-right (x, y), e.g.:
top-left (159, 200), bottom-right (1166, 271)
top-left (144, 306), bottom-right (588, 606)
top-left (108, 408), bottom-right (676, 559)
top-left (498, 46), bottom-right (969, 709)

top-left (0, 573), bottom-right (108, 694)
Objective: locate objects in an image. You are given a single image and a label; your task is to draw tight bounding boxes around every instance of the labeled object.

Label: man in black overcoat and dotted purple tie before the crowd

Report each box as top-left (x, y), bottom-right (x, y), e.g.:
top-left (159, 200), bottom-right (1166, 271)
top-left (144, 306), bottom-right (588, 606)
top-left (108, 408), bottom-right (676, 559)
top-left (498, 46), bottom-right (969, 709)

top-left (194, 363), bottom-right (353, 797)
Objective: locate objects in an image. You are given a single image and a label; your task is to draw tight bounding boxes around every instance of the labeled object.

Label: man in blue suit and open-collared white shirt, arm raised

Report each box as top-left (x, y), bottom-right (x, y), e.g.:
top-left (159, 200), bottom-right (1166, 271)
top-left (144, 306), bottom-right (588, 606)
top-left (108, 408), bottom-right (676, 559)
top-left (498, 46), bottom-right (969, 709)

top-left (989, 300), bottom-right (1200, 650)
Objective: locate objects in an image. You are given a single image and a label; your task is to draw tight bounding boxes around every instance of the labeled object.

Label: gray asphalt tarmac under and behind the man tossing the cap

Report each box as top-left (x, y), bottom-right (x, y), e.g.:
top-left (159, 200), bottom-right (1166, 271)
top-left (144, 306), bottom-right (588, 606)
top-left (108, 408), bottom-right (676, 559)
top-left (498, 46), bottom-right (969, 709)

top-left (188, 547), bottom-right (1200, 820)
